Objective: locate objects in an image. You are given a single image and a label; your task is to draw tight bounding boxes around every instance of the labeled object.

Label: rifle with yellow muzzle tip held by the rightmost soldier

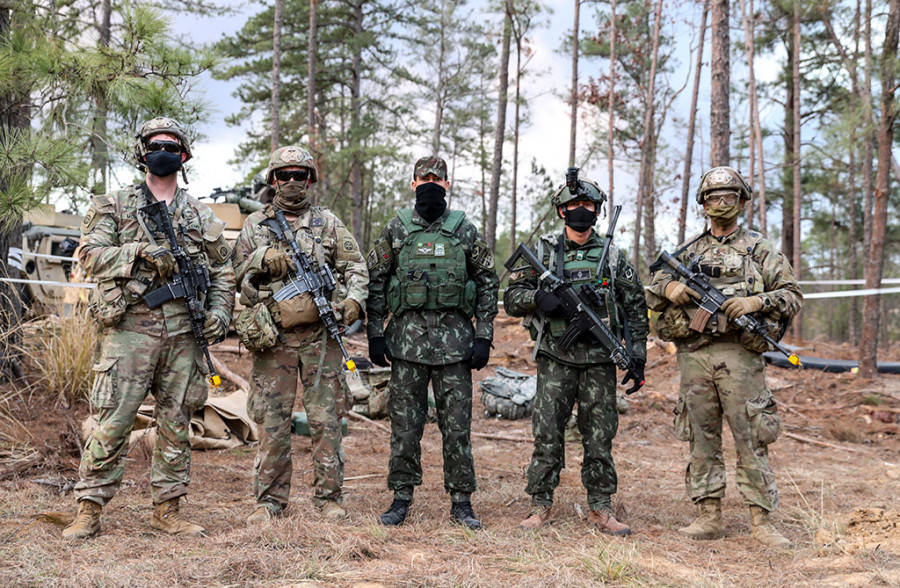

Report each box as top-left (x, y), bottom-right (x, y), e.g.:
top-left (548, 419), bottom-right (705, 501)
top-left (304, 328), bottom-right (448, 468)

top-left (650, 251), bottom-right (800, 367)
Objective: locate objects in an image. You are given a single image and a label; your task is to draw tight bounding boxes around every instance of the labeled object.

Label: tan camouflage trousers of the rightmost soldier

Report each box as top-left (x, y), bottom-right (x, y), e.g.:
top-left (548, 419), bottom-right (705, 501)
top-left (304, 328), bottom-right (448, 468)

top-left (675, 343), bottom-right (781, 511)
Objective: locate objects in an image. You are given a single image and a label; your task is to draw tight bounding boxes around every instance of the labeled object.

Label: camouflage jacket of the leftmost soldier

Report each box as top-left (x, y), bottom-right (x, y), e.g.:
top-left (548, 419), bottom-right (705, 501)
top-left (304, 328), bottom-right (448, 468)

top-left (78, 184), bottom-right (235, 337)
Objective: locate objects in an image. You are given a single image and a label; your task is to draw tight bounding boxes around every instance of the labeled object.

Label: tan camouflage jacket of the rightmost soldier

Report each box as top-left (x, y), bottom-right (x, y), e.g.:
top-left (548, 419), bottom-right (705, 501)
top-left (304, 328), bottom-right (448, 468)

top-left (647, 227), bottom-right (803, 350)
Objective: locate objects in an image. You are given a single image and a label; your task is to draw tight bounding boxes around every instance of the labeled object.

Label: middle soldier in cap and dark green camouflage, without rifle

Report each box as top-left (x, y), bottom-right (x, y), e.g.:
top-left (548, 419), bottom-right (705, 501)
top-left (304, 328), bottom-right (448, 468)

top-left (366, 157), bottom-right (499, 529)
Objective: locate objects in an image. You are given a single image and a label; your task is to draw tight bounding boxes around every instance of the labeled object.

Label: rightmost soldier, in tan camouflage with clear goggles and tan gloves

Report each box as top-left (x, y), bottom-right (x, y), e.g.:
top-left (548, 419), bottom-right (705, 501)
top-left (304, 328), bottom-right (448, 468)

top-left (647, 167), bottom-right (803, 546)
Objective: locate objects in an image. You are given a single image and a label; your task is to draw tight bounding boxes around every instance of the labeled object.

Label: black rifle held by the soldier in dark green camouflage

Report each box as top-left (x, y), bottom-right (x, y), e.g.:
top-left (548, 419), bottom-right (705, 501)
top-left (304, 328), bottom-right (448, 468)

top-left (504, 206), bottom-right (644, 378)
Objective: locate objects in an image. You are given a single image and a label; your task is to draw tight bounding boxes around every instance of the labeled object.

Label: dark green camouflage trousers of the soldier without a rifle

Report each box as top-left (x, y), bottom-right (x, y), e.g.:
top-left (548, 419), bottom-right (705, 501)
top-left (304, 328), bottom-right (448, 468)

top-left (388, 359), bottom-right (475, 502)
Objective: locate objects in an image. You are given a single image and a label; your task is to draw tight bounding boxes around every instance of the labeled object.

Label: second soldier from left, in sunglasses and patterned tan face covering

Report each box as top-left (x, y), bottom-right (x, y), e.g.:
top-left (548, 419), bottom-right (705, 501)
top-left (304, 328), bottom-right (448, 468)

top-left (236, 146), bottom-right (369, 524)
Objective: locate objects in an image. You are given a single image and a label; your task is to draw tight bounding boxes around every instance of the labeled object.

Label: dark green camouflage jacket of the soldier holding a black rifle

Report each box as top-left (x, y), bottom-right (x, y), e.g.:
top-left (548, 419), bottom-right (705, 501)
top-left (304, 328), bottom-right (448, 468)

top-left (503, 232), bottom-right (649, 366)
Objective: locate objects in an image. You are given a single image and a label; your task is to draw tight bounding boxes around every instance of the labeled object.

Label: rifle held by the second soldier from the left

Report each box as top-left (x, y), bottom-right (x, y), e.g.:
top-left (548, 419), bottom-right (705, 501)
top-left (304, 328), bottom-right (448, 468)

top-left (260, 210), bottom-right (356, 372)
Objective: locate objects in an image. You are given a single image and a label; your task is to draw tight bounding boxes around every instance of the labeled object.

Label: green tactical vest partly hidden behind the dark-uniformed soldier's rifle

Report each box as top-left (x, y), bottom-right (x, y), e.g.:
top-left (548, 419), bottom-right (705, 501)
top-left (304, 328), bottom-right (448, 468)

top-left (531, 235), bottom-right (622, 339)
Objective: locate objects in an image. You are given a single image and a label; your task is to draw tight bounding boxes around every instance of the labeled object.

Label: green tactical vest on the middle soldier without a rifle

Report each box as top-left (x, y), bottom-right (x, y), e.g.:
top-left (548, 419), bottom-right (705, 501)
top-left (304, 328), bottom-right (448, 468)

top-left (387, 208), bottom-right (475, 317)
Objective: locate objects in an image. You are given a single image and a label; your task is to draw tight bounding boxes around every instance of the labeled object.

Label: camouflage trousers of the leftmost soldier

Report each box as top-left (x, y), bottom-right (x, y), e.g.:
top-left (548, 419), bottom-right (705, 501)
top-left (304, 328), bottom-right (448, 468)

top-left (75, 329), bottom-right (208, 505)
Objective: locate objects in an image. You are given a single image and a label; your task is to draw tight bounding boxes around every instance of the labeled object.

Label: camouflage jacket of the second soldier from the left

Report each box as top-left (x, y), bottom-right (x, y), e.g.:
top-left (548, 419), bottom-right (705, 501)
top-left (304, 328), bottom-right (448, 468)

top-left (236, 204), bottom-right (369, 344)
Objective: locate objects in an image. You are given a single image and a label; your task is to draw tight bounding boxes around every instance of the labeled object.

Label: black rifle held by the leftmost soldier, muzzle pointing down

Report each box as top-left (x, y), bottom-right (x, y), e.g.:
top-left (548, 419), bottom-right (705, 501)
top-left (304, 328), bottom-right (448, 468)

top-left (140, 201), bottom-right (222, 388)
